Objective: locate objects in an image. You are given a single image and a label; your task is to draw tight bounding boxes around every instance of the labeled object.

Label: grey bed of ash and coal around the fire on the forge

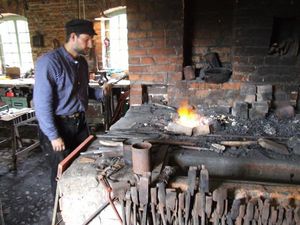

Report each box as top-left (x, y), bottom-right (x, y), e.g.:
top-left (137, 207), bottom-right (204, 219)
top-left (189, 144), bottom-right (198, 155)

top-left (110, 104), bottom-right (300, 161)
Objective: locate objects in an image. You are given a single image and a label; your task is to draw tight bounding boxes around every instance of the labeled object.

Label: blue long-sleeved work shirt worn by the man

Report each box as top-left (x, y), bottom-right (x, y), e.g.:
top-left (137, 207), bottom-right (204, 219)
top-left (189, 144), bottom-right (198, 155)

top-left (33, 47), bottom-right (103, 140)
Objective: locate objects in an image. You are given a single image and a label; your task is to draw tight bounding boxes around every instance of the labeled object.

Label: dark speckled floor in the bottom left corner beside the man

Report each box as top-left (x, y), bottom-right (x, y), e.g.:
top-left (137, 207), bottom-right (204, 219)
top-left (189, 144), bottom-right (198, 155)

top-left (0, 148), bottom-right (53, 225)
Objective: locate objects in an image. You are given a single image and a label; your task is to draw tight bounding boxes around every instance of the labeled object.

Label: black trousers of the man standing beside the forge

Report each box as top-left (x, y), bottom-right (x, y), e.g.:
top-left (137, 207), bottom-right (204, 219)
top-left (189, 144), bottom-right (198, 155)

top-left (39, 114), bottom-right (89, 196)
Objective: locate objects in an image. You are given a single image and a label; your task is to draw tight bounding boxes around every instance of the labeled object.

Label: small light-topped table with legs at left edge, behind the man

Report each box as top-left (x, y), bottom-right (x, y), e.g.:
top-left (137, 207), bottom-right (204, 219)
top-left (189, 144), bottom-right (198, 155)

top-left (0, 108), bottom-right (39, 169)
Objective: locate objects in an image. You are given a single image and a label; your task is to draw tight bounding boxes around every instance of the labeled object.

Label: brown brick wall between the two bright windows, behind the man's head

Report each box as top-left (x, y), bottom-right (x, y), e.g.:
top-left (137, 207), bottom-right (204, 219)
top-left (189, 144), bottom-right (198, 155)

top-left (25, 0), bottom-right (125, 66)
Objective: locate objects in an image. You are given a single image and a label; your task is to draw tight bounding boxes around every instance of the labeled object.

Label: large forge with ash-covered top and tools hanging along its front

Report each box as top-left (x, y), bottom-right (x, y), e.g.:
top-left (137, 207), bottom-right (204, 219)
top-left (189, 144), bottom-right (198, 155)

top-left (58, 104), bottom-right (300, 224)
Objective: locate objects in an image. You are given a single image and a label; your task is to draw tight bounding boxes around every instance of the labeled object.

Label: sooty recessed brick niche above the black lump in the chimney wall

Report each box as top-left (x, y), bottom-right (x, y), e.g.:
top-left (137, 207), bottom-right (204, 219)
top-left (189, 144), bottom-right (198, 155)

top-left (191, 0), bottom-right (234, 68)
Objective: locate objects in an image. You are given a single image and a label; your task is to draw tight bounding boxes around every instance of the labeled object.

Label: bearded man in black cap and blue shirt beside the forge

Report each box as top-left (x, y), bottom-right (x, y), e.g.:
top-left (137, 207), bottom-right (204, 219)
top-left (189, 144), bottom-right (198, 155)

top-left (33, 19), bottom-right (111, 194)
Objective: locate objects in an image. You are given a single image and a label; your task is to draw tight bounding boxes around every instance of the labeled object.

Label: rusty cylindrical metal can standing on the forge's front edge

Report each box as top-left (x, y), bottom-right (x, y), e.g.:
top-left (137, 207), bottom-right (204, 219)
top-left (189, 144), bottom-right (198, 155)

top-left (131, 141), bottom-right (152, 175)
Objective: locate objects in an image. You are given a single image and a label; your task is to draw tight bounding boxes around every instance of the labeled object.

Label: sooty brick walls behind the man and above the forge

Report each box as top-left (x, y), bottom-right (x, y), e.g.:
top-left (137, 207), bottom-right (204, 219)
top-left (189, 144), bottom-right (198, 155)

top-left (2, 0), bottom-right (300, 109)
